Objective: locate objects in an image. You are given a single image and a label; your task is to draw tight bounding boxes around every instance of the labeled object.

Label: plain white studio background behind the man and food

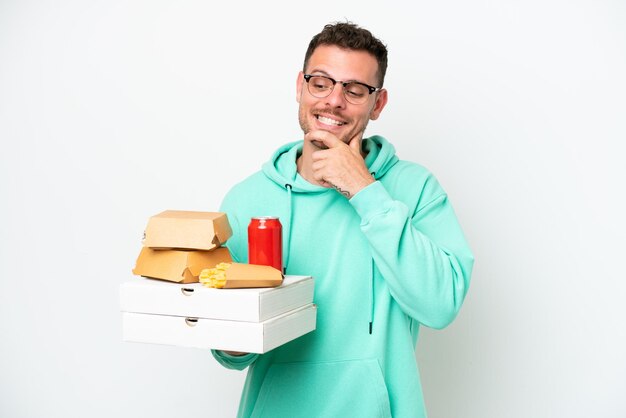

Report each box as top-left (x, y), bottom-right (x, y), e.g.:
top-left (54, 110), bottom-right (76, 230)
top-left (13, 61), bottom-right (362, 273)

top-left (0, 0), bottom-right (626, 418)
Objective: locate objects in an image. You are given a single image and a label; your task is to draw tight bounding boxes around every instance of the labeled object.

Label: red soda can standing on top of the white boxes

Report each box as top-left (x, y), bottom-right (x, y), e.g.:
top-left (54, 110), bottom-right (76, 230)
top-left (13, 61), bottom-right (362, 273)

top-left (248, 216), bottom-right (283, 273)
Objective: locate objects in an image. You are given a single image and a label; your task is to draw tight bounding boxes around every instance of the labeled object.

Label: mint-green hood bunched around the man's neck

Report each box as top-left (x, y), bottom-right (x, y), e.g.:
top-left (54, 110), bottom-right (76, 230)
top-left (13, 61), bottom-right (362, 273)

top-left (263, 135), bottom-right (398, 193)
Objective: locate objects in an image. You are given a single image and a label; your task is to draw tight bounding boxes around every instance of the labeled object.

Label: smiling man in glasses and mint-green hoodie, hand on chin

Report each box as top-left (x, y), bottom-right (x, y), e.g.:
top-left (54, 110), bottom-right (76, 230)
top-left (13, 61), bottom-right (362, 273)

top-left (213, 23), bottom-right (473, 418)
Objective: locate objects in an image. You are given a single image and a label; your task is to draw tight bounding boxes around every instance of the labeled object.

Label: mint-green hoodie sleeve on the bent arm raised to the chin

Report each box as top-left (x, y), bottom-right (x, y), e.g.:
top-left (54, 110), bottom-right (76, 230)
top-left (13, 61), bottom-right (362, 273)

top-left (350, 176), bottom-right (474, 329)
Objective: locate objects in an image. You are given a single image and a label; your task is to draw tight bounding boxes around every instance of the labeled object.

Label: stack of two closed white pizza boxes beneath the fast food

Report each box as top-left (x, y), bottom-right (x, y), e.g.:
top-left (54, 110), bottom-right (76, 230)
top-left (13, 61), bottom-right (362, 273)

top-left (120, 275), bottom-right (317, 353)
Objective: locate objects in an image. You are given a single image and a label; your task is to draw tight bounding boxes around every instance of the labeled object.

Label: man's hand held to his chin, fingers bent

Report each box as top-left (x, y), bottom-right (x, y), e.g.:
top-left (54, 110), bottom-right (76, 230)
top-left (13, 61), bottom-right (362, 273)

top-left (304, 130), bottom-right (374, 199)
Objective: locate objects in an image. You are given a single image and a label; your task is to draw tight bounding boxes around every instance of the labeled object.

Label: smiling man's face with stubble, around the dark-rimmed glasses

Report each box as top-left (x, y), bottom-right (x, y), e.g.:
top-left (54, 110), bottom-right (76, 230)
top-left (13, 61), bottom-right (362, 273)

top-left (296, 45), bottom-right (387, 143)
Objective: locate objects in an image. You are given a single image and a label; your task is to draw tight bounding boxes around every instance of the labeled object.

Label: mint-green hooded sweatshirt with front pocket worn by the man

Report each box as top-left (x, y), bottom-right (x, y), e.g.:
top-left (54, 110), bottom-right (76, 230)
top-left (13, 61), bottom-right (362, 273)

top-left (213, 136), bottom-right (473, 418)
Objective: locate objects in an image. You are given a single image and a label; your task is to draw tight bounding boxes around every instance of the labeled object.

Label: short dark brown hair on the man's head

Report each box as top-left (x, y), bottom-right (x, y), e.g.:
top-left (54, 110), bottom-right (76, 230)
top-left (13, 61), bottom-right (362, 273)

top-left (303, 22), bottom-right (387, 87)
